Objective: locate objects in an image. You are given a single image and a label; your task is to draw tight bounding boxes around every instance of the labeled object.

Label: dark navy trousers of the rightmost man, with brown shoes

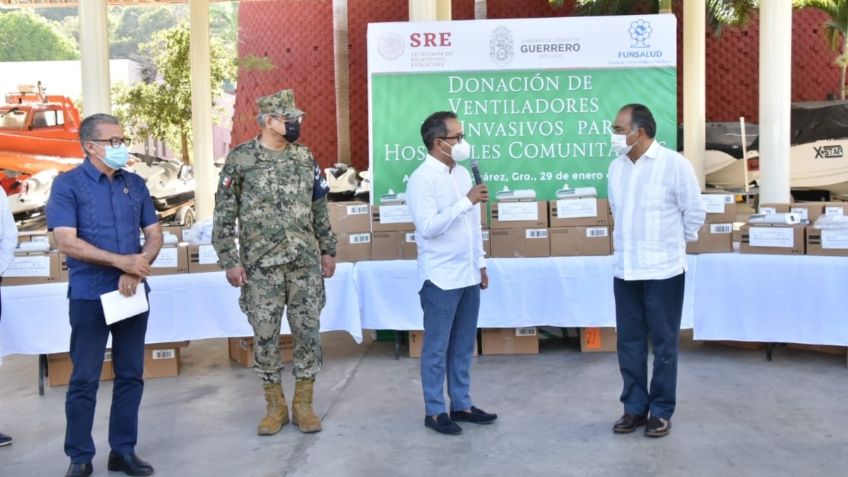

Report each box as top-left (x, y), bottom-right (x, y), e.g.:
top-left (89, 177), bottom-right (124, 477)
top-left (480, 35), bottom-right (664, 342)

top-left (613, 273), bottom-right (685, 419)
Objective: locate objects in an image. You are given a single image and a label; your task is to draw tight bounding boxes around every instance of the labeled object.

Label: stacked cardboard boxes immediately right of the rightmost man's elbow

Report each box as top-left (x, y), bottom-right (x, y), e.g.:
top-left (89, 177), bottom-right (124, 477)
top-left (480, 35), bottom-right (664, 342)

top-left (686, 194), bottom-right (736, 254)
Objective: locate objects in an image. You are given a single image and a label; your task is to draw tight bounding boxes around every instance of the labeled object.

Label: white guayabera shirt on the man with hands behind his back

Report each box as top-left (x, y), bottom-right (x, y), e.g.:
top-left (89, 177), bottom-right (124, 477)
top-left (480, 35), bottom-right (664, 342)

top-left (609, 141), bottom-right (706, 280)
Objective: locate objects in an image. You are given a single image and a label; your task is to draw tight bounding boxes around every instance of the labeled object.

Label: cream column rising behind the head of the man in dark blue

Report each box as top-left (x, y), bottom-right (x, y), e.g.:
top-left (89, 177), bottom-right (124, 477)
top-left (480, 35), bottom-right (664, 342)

top-left (78, 0), bottom-right (112, 116)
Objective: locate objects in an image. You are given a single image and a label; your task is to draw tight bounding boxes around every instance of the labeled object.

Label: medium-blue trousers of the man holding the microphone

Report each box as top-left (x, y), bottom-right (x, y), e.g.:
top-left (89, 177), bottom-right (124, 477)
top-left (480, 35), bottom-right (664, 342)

top-left (418, 280), bottom-right (480, 416)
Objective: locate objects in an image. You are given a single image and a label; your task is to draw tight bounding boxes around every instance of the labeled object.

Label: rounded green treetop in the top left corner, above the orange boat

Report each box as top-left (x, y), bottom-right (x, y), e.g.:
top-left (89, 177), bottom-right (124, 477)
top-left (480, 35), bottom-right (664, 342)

top-left (0, 10), bottom-right (79, 61)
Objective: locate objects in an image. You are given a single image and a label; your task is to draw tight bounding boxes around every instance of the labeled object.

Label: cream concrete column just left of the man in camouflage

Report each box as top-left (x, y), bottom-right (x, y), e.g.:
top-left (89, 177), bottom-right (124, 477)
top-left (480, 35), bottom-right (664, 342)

top-left (189, 0), bottom-right (216, 220)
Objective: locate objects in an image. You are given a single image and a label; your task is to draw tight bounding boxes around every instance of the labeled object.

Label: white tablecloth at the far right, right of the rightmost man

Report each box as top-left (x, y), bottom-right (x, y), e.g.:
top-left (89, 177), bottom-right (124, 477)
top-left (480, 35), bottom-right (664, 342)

top-left (695, 253), bottom-right (848, 346)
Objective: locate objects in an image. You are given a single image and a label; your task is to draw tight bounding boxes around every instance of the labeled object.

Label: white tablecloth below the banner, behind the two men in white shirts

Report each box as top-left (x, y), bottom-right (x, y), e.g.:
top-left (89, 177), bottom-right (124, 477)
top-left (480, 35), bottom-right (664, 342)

top-left (354, 255), bottom-right (697, 330)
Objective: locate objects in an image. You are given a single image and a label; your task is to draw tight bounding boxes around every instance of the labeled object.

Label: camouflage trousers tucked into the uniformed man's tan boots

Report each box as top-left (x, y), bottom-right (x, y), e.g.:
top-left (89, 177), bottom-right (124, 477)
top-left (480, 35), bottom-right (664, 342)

top-left (239, 263), bottom-right (326, 383)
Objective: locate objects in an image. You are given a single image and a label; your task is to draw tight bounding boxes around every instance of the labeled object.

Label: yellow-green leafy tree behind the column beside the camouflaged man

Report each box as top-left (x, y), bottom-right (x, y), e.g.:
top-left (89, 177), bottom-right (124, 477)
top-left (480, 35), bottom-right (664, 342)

top-left (113, 23), bottom-right (234, 164)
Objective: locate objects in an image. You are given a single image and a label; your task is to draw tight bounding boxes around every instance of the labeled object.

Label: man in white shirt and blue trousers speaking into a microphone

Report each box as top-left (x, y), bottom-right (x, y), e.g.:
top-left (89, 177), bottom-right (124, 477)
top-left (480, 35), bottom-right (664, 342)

top-left (406, 111), bottom-right (497, 435)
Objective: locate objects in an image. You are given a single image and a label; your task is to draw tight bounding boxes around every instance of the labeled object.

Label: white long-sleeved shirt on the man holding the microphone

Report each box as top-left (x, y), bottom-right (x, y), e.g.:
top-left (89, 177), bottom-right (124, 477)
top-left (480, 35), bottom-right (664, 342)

top-left (406, 154), bottom-right (486, 290)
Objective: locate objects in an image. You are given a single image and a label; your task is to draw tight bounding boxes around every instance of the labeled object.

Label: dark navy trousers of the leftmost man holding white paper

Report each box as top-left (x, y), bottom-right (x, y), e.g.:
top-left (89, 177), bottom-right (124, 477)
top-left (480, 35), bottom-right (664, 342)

top-left (65, 298), bottom-right (148, 464)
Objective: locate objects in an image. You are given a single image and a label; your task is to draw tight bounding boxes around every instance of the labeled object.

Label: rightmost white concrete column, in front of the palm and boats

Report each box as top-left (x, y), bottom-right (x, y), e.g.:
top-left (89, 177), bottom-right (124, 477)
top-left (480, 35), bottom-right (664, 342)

top-left (760, 0), bottom-right (792, 203)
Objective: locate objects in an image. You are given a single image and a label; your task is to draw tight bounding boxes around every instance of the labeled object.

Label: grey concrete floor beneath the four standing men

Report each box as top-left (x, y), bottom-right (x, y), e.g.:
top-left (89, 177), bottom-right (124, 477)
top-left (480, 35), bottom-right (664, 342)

top-left (0, 333), bottom-right (848, 477)
